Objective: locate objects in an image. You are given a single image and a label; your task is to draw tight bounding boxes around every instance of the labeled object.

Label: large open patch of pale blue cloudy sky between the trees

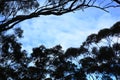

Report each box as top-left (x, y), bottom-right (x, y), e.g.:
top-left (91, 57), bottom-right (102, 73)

top-left (18, 3), bottom-right (120, 53)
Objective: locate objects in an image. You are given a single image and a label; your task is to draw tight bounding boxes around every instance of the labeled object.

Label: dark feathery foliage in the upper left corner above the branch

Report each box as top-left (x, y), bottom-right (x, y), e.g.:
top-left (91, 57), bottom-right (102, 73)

top-left (0, 0), bottom-right (39, 18)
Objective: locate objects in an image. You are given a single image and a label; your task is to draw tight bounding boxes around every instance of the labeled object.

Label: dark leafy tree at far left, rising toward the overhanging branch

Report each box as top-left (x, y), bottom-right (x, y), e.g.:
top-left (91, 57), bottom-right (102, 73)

top-left (0, 28), bottom-right (29, 80)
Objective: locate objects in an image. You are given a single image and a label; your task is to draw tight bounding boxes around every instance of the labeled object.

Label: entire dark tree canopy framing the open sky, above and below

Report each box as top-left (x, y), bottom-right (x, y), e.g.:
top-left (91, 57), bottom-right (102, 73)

top-left (0, 0), bottom-right (120, 80)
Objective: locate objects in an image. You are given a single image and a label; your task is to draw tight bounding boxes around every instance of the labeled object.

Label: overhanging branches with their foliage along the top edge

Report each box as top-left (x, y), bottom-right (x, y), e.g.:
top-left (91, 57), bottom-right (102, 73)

top-left (0, 0), bottom-right (120, 32)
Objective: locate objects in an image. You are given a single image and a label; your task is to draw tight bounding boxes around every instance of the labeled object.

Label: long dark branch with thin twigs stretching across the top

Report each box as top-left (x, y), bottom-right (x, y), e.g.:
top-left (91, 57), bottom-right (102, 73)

top-left (0, 0), bottom-right (120, 32)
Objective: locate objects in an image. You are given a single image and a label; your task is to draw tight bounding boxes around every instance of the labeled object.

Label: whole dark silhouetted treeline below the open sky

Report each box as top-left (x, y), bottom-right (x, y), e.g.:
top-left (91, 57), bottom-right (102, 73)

top-left (0, 22), bottom-right (120, 80)
